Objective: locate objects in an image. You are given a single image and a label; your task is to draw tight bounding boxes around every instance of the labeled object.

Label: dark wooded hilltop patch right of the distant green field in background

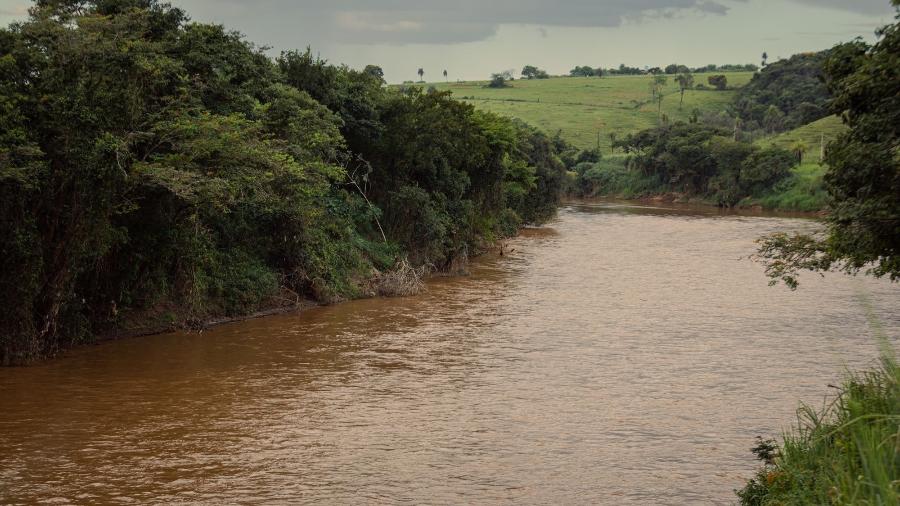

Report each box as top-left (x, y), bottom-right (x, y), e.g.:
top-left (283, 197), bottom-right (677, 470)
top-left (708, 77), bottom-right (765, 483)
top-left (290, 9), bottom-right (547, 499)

top-left (735, 51), bottom-right (831, 133)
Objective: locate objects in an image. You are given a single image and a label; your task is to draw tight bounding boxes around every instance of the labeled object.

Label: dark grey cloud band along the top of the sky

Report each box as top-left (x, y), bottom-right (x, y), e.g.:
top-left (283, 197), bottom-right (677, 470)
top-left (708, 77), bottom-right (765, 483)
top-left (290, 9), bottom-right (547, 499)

top-left (175, 0), bottom-right (728, 44)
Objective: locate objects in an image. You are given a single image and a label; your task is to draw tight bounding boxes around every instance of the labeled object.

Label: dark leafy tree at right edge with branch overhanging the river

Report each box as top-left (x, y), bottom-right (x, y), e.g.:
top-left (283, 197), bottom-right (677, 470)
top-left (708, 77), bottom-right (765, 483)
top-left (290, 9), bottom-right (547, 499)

top-left (759, 0), bottom-right (900, 288)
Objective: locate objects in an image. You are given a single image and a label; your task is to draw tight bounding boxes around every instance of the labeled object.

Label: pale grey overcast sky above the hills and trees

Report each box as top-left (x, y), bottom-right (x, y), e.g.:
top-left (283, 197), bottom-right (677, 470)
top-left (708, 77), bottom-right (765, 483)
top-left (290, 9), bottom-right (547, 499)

top-left (0, 0), bottom-right (894, 82)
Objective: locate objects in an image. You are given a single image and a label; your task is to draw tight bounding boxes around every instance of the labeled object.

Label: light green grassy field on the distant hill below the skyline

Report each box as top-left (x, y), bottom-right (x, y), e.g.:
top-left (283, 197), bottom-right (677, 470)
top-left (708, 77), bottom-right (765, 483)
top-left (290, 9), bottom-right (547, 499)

top-left (420, 72), bottom-right (753, 153)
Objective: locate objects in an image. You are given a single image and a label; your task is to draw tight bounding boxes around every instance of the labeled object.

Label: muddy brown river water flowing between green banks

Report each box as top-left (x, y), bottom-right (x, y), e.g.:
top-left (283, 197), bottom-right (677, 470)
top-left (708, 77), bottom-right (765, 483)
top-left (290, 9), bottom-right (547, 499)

top-left (0, 202), bottom-right (900, 504)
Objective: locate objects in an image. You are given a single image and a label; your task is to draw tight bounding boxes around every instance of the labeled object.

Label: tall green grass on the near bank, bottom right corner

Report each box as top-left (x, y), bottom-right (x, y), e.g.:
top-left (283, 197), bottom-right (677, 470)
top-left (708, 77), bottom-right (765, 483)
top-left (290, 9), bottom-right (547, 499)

top-left (737, 350), bottom-right (900, 506)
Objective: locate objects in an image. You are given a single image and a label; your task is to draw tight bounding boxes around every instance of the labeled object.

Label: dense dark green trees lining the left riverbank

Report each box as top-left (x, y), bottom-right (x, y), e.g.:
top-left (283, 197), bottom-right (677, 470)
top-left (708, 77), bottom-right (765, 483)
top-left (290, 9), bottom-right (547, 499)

top-left (0, 0), bottom-right (564, 364)
